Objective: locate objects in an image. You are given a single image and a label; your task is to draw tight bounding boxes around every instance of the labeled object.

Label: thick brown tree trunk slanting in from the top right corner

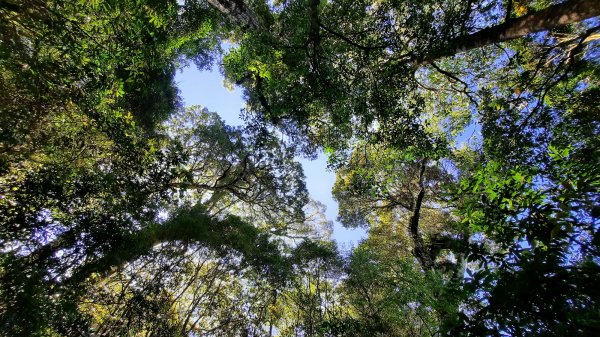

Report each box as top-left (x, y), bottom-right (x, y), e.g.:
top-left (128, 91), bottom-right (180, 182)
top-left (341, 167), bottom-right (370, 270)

top-left (419, 0), bottom-right (600, 63)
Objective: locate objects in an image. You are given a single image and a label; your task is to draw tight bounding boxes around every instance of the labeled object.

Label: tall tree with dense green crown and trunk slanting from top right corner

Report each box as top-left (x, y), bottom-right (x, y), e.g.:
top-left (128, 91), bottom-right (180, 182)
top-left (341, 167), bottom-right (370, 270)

top-left (224, 1), bottom-right (598, 155)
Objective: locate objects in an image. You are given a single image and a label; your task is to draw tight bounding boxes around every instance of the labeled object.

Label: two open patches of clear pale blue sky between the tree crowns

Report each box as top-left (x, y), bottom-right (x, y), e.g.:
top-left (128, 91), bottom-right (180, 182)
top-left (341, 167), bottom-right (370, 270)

top-left (175, 66), bottom-right (366, 250)
